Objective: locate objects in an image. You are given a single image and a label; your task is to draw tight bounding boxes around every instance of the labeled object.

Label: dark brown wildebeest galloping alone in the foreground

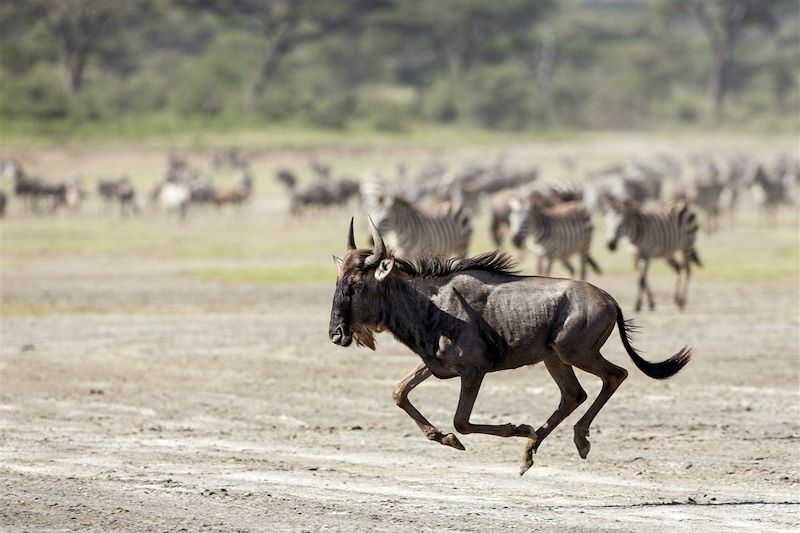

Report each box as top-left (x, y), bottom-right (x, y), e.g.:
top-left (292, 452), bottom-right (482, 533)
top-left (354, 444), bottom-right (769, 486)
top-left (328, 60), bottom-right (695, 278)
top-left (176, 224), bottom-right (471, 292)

top-left (328, 219), bottom-right (691, 475)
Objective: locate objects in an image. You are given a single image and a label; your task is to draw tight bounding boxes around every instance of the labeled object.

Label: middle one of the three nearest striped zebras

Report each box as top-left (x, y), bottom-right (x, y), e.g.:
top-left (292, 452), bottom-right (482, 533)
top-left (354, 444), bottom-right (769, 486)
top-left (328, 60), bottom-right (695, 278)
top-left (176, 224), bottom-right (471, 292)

top-left (509, 198), bottom-right (600, 280)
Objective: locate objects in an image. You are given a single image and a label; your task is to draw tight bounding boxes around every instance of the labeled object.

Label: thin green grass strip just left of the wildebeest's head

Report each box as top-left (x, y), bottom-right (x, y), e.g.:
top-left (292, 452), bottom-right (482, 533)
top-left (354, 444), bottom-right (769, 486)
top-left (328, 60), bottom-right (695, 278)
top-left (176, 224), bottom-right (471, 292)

top-left (183, 263), bottom-right (336, 284)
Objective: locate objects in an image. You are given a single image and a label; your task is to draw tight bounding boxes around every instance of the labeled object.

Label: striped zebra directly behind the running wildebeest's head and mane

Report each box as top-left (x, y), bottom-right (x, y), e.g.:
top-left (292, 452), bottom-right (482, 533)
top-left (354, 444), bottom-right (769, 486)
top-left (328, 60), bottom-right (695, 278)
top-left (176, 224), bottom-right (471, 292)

top-left (369, 195), bottom-right (472, 259)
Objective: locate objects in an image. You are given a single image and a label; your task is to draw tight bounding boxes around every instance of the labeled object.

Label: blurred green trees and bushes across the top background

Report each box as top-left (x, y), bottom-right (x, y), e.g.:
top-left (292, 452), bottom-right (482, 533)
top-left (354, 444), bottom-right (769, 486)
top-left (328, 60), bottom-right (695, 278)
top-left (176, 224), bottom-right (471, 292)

top-left (0, 0), bottom-right (800, 140)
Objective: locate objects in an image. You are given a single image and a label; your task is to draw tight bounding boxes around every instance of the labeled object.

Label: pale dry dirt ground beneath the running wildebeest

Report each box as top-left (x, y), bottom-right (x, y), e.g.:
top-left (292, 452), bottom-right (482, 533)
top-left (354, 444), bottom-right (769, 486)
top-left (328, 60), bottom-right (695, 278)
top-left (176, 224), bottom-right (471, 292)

top-left (0, 139), bottom-right (800, 532)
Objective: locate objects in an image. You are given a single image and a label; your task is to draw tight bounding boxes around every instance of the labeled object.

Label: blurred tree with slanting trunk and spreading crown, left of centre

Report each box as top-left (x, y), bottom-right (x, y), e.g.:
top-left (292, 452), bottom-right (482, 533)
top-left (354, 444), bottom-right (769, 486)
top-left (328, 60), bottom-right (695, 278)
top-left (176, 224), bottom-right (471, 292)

top-left (178, 0), bottom-right (392, 110)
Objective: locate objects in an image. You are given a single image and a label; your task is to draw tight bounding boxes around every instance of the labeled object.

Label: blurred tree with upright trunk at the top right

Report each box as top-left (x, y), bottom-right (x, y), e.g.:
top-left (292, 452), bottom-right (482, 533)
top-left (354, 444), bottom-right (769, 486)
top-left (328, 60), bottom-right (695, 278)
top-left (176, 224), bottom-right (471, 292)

top-left (662, 0), bottom-right (786, 122)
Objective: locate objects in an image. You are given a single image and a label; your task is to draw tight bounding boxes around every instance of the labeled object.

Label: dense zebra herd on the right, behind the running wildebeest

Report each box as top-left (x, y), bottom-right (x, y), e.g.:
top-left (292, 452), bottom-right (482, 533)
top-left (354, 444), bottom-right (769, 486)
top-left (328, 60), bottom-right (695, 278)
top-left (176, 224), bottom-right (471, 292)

top-left (318, 151), bottom-right (800, 311)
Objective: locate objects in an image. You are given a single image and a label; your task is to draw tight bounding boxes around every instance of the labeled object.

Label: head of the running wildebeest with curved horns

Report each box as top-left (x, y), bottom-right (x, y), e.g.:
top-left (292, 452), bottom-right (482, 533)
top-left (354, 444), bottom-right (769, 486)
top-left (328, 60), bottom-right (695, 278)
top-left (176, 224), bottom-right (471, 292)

top-left (328, 219), bottom-right (394, 350)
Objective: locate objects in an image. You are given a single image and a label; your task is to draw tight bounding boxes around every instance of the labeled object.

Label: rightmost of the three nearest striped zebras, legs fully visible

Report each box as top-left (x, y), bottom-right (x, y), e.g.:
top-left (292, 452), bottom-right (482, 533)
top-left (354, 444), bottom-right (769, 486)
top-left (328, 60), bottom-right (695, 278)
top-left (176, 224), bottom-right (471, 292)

top-left (606, 202), bottom-right (702, 312)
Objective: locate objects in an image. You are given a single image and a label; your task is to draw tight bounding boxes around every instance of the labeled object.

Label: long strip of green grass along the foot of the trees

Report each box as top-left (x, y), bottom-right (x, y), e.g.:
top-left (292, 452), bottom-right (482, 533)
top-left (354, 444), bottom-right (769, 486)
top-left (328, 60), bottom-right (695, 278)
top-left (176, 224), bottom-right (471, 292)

top-left (0, 113), bottom-right (585, 148)
